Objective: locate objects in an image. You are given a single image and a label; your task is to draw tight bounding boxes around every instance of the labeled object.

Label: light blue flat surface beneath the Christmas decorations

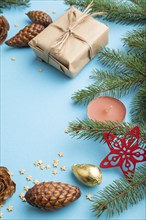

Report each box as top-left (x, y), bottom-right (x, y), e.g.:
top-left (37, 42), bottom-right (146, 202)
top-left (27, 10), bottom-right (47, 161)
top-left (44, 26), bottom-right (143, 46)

top-left (0, 0), bottom-right (146, 220)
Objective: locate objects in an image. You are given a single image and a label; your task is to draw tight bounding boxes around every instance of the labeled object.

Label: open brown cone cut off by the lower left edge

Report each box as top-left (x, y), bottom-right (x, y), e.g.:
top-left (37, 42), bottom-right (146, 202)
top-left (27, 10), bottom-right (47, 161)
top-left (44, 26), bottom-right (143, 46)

top-left (0, 167), bottom-right (16, 205)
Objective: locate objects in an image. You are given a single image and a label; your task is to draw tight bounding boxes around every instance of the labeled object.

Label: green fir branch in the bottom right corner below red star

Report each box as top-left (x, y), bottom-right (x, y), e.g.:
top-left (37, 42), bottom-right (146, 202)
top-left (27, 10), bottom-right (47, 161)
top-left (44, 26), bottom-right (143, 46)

top-left (92, 164), bottom-right (146, 219)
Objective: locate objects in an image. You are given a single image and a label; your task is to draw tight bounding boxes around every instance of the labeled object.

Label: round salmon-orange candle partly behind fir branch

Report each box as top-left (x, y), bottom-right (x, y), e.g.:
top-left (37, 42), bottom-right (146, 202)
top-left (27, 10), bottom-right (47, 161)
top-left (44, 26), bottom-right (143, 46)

top-left (87, 96), bottom-right (126, 122)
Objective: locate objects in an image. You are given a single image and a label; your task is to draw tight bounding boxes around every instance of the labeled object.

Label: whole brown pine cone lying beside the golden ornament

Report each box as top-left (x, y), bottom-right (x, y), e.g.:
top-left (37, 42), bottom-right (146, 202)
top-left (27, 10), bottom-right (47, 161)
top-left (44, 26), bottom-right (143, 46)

top-left (25, 182), bottom-right (81, 210)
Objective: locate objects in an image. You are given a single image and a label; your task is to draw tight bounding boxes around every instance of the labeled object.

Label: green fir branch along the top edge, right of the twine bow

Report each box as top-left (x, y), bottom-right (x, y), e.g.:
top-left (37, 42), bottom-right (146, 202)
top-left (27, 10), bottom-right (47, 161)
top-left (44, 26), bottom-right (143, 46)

top-left (65, 0), bottom-right (146, 24)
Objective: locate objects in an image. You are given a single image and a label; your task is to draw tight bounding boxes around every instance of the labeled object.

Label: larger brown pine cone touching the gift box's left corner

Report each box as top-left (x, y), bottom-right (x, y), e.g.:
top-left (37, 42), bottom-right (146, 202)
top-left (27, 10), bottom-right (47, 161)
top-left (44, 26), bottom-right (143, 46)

top-left (5, 24), bottom-right (45, 47)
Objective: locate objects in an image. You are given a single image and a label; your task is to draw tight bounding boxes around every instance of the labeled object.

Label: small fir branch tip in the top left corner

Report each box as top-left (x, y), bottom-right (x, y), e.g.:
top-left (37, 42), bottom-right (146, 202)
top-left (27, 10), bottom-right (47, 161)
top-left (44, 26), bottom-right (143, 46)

top-left (0, 0), bottom-right (30, 13)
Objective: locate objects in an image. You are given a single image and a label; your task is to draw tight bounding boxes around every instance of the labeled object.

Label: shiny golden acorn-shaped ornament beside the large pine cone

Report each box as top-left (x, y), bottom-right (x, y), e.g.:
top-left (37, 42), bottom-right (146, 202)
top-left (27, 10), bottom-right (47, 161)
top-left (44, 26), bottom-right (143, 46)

top-left (72, 164), bottom-right (102, 187)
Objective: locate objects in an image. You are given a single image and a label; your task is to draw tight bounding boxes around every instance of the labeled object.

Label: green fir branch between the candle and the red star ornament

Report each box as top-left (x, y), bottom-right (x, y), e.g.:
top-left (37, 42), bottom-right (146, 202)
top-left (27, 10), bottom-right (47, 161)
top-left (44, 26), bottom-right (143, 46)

top-left (67, 119), bottom-right (146, 144)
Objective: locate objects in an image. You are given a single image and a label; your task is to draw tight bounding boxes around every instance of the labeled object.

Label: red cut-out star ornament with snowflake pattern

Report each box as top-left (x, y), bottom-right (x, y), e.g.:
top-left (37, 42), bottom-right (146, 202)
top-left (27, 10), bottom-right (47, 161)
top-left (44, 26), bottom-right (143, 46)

top-left (100, 126), bottom-right (146, 176)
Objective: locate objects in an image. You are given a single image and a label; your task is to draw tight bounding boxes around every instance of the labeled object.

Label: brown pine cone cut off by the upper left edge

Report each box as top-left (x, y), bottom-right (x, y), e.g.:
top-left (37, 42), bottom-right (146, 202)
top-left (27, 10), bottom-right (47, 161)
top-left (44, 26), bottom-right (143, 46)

top-left (0, 16), bottom-right (10, 44)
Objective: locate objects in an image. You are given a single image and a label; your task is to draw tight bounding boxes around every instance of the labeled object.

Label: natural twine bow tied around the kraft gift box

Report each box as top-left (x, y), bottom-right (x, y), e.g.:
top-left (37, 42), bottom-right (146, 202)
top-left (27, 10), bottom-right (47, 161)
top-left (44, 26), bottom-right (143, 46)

top-left (51, 2), bottom-right (99, 59)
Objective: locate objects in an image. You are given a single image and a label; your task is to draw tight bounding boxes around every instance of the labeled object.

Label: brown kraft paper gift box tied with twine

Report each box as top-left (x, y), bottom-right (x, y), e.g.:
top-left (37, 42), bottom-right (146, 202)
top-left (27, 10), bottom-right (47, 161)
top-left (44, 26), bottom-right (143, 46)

top-left (29, 5), bottom-right (108, 77)
